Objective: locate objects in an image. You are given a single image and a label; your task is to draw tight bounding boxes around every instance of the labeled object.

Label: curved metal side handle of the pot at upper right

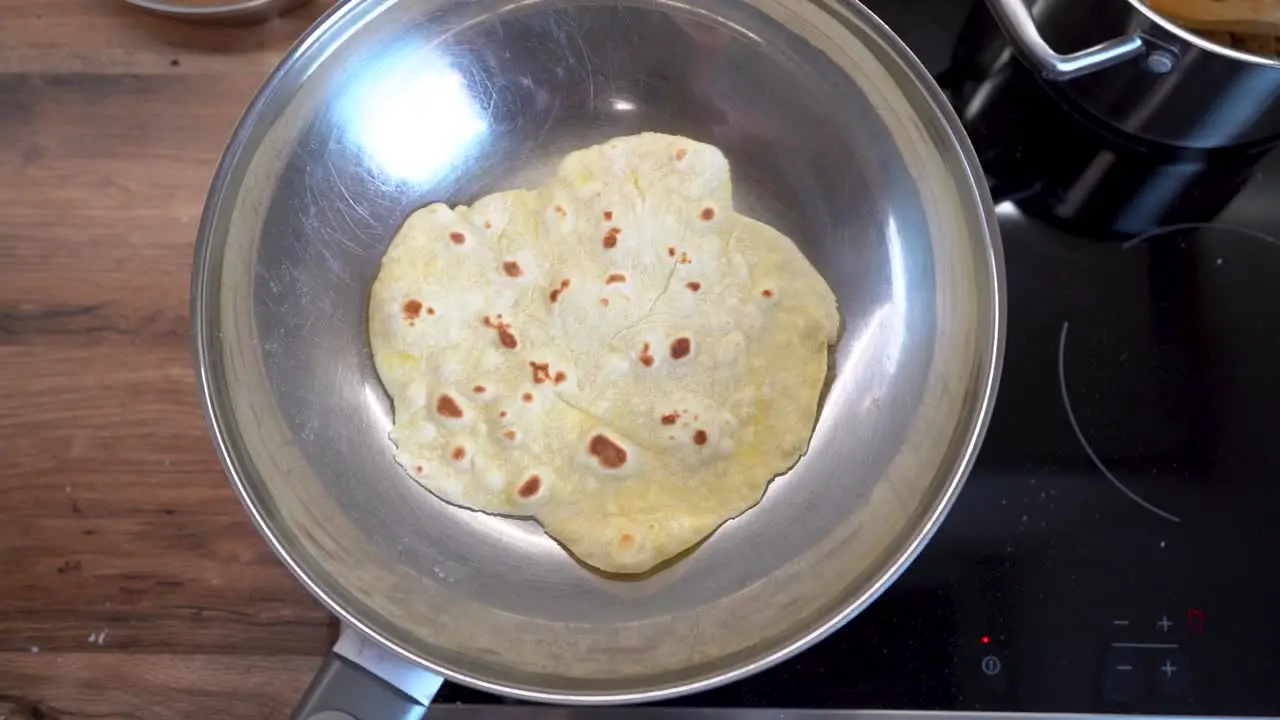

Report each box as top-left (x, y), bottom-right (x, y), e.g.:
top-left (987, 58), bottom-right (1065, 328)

top-left (987, 0), bottom-right (1143, 81)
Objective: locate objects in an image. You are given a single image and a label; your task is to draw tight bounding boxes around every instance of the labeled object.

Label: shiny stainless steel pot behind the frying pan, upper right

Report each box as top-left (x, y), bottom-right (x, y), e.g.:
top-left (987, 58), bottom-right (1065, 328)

top-left (987, 0), bottom-right (1280, 149)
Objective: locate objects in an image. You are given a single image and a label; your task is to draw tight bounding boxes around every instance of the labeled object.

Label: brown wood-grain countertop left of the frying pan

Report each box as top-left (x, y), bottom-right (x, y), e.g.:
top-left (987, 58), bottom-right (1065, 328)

top-left (0, 0), bottom-right (337, 720)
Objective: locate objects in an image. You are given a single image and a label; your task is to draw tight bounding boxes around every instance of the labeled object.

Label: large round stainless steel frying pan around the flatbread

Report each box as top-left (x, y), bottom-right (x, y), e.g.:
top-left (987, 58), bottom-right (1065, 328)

top-left (192, 0), bottom-right (1004, 719)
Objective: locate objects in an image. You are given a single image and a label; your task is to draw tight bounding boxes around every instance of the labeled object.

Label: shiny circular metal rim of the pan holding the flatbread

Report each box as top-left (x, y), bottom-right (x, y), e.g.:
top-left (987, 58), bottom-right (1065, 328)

top-left (189, 0), bottom-right (1006, 706)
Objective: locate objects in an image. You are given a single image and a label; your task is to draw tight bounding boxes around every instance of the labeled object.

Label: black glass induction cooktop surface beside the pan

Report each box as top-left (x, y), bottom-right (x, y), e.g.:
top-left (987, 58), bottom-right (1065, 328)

top-left (436, 0), bottom-right (1280, 715)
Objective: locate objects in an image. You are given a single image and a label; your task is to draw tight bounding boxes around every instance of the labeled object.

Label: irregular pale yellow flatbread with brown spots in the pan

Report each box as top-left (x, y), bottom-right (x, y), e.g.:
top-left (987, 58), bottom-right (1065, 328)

top-left (369, 133), bottom-right (840, 573)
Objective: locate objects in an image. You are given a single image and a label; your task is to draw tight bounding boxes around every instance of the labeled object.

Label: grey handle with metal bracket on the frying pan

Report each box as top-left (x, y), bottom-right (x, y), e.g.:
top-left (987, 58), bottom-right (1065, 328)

top-left (292, 625), bottom-right (444, 720)
